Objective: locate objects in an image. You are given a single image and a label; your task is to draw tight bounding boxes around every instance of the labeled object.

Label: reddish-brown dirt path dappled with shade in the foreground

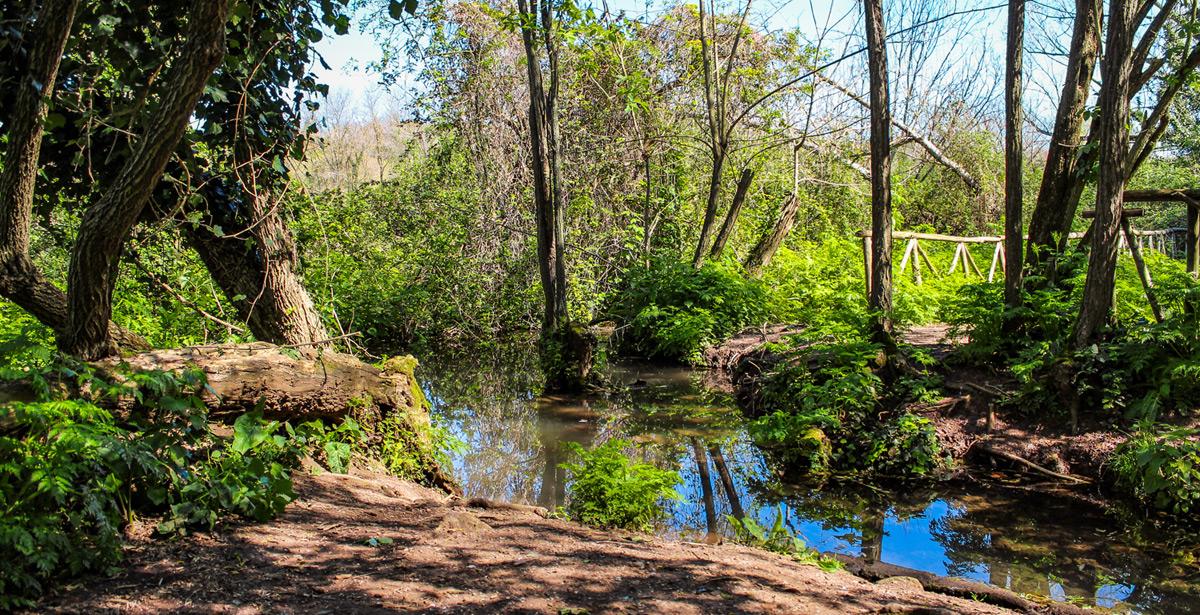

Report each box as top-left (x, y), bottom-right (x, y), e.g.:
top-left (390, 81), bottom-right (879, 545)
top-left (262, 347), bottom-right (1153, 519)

top-left (38, 472), bottom-right (1008, 614)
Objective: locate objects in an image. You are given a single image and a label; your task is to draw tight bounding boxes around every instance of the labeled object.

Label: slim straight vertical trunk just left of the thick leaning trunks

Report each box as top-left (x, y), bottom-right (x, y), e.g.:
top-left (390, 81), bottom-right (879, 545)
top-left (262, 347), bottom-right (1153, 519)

top-left (1004, 0), bottom-right (1025, 309)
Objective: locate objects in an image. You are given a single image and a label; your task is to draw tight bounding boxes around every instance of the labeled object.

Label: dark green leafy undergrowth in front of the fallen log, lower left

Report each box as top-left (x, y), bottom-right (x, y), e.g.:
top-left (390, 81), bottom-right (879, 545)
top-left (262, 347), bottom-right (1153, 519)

top-left (0, 360), bottom-right (305, 609)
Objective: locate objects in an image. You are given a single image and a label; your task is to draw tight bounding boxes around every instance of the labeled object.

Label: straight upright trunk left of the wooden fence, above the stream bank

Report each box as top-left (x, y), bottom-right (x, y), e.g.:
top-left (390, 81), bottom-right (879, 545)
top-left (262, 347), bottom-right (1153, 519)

top-left (863, 0), bottom-right (895, 347)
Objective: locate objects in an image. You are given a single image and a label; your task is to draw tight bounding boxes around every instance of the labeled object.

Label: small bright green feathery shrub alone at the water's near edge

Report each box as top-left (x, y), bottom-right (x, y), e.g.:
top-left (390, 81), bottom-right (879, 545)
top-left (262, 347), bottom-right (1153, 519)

top-left (563, 440), bottom-right (680, 530)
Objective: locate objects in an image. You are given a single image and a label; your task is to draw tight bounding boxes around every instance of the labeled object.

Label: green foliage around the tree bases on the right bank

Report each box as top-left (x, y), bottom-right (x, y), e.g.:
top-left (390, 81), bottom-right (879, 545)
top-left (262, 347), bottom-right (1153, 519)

top-left (946, 252), bottom-right (1200, 419)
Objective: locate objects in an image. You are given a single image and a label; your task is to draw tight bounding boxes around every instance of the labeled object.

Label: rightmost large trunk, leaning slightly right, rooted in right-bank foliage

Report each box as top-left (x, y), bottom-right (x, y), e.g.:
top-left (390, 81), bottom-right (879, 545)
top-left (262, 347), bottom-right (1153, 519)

top-left (1074, 0), bottom-right (1138, 348)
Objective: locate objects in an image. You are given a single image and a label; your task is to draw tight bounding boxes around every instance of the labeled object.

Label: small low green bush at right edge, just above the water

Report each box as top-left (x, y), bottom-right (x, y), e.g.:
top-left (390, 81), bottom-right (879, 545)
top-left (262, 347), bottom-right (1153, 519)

top-left (1111, 425), bottom-right (1200, 515)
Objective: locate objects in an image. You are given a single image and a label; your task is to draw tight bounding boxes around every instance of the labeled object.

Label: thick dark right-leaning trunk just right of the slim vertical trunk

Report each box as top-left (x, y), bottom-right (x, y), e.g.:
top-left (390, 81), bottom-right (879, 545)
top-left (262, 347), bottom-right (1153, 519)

top-left (1027, 0), bottom-right (1100, 268)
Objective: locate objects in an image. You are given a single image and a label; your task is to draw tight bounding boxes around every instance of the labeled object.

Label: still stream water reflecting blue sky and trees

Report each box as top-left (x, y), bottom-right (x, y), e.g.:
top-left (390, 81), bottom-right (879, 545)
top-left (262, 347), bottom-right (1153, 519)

top-left (420, 352), bottom-right (1200, 614)
